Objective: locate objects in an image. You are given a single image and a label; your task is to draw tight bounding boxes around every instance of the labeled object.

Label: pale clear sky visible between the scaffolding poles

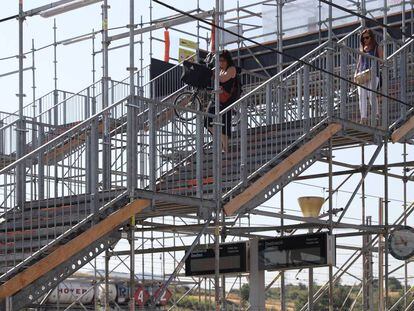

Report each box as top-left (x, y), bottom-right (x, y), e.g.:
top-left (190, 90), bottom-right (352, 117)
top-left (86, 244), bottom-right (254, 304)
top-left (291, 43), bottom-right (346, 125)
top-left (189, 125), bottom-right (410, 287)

top-left (0, 0), bottom-right (414, 294)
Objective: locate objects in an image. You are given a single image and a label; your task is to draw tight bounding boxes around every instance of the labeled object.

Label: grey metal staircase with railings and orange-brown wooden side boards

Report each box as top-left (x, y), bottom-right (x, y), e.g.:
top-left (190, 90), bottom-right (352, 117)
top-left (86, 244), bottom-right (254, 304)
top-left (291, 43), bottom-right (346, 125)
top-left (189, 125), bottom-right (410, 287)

top-left (0, 25), bottom-right (414, 309)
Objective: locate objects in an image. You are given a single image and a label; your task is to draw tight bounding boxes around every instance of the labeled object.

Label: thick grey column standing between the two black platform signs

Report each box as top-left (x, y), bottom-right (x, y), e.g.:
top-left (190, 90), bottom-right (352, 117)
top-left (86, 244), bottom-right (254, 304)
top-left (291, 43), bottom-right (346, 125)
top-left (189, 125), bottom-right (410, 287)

top-left (249, 239), bottom-right (265, 311)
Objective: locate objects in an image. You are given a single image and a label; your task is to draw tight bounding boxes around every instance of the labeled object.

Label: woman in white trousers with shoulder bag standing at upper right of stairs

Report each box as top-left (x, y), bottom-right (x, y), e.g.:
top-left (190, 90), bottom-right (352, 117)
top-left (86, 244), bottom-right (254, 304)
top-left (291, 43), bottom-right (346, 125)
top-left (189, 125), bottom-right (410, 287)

top-left (355, 29), bottom-right (383, 124)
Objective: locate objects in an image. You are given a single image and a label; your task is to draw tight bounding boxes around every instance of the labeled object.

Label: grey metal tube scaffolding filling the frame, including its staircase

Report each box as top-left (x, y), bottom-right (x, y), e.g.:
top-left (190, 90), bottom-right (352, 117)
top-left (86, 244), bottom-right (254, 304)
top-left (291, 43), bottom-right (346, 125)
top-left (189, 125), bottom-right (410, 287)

top-left (0, 0), bottom-right (414, 311)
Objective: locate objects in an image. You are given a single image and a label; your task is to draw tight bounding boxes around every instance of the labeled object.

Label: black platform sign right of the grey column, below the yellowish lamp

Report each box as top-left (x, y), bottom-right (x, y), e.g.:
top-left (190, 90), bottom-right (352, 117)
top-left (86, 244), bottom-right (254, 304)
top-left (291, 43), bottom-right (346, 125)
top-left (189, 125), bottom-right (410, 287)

top-left (259, 233), bottom-right (335, 270)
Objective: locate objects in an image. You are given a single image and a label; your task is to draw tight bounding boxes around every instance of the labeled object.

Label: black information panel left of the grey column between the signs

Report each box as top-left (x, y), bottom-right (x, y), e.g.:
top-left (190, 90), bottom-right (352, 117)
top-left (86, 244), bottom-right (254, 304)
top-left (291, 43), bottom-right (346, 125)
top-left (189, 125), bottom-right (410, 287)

top-left (185, 242), bottom-right (247, 276)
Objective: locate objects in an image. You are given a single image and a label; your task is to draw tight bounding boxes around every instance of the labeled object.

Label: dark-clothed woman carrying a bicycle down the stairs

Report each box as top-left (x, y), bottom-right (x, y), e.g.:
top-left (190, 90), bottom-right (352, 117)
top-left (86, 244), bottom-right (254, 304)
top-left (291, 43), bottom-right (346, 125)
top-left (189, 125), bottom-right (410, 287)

top-left (206, 50), bottom-right (239, 152)
